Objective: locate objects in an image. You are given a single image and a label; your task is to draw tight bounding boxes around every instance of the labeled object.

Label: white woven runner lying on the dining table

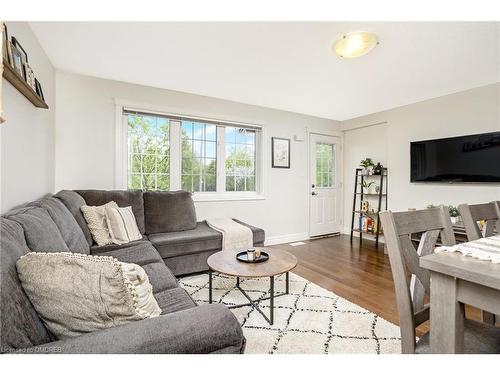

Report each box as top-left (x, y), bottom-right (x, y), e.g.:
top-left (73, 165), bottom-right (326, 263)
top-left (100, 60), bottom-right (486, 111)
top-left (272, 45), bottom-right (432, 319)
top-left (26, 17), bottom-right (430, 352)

top-left (435, 235), bottom-right (500, 263)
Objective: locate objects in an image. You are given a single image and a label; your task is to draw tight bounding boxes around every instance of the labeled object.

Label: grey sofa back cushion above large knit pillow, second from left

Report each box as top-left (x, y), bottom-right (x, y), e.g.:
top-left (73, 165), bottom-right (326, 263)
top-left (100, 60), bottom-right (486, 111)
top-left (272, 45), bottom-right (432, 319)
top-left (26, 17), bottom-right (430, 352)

top-left (7, 207), bottom-right (69, 252)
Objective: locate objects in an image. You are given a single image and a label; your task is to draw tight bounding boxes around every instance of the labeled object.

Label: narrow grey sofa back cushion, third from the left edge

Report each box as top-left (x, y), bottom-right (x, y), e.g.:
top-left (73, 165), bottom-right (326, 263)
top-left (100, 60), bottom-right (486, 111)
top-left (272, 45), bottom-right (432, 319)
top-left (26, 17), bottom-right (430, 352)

top-left (35, 197), bottom-right (90, 254)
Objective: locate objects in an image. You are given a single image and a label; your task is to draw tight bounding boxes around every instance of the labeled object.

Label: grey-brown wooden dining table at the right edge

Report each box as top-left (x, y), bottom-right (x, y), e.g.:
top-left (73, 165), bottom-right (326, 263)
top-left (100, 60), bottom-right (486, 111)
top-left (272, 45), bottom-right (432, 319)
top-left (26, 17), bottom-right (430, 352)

top-left (420, 236), bottom-right (500, 354)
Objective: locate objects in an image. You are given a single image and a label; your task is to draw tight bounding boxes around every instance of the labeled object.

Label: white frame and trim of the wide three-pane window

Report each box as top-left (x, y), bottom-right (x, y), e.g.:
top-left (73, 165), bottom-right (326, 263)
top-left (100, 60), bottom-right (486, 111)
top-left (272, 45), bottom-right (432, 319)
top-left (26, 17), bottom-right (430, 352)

top-left (115, 99), bottom-right (267, 202)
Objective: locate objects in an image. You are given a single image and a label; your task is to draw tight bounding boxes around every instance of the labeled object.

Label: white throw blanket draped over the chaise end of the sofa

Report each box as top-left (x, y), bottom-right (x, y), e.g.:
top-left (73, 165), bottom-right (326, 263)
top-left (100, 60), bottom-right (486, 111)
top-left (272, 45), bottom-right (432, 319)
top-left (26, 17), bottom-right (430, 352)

top-left (207, 218), bottom-right (253, 251)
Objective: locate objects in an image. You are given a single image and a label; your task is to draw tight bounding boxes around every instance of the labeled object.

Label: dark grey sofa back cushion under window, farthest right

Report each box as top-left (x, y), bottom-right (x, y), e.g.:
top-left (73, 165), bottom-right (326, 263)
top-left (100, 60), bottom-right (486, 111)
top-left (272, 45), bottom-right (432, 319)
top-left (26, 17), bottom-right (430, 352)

top-left (144, 191), bottom-right (196, 234)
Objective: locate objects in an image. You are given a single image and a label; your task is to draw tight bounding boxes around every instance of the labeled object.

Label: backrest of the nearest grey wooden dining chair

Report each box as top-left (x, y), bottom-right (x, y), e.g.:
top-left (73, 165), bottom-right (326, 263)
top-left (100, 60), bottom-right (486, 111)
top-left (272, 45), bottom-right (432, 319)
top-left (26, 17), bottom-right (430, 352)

top-left (380, 206), bottom-right (456, 353)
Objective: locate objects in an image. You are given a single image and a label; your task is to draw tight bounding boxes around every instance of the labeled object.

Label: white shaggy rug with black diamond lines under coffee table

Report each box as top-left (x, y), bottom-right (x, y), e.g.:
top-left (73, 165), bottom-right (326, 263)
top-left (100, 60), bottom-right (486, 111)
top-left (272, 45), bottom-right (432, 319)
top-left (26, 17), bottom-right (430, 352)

top-left (179, 273), bottom-right (401, 354)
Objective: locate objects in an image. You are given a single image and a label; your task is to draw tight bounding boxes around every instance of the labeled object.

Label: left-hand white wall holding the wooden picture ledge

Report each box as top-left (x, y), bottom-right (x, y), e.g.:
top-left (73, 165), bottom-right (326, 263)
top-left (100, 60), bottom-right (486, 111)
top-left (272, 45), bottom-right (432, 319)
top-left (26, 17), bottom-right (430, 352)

top-left (0, 22), bottom-right (55, 213)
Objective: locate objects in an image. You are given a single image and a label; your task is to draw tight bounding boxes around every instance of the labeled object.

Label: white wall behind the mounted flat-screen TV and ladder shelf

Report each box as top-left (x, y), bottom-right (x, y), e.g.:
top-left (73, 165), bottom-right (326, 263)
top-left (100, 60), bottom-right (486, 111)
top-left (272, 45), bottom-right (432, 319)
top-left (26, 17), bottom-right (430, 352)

top-left (341, 83), bottom-right (500, 232)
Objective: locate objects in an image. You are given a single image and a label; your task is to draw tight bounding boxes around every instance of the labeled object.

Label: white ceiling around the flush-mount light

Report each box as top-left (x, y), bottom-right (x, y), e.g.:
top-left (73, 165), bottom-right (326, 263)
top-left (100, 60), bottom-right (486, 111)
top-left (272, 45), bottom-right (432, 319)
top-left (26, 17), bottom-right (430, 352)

top-left (31, 22), bottom-right (500, 120)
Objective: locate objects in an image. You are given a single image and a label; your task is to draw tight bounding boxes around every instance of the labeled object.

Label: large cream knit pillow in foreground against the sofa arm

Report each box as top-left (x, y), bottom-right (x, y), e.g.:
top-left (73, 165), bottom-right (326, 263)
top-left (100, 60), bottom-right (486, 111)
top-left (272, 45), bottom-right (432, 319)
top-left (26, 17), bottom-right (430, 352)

top-left (16, 252), bottom-right (161, 339)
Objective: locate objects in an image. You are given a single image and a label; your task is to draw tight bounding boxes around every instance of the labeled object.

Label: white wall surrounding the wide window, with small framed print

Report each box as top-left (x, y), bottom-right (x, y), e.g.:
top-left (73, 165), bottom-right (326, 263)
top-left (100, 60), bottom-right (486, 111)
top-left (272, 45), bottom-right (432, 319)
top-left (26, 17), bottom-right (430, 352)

top-left (55, 72), bottom-right (339, 241)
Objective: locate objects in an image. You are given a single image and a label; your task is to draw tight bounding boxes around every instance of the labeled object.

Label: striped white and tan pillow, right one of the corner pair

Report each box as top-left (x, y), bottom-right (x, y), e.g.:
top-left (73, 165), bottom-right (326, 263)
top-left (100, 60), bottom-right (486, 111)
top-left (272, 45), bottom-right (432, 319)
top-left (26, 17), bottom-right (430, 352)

top-left (106, 206), bottom-right (142, 245)
